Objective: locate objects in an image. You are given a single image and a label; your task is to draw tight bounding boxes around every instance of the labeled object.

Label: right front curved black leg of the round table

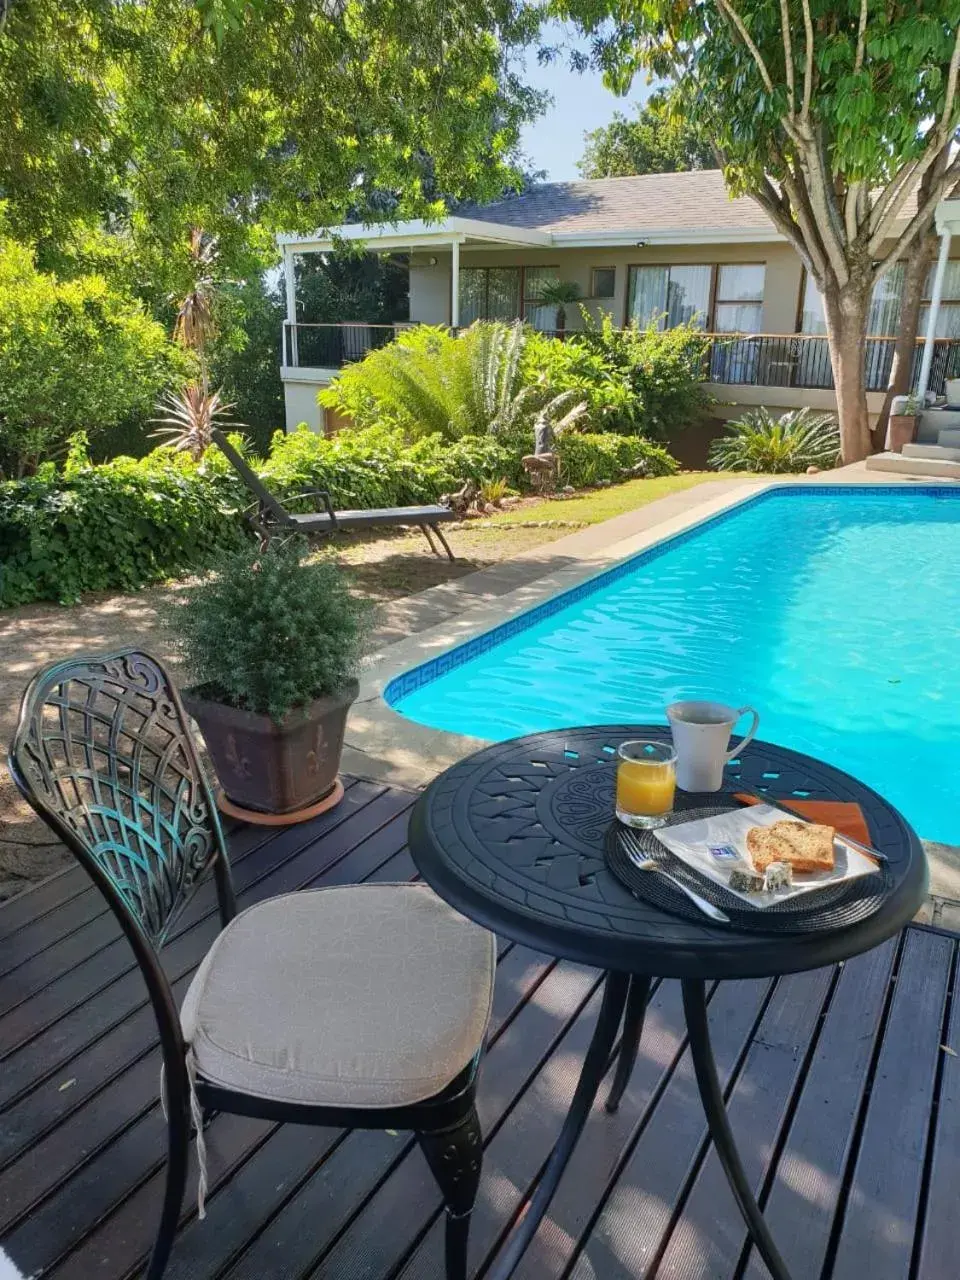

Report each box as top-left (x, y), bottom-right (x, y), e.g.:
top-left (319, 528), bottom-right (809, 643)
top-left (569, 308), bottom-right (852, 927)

top-left (684, 978), bottom-right (791, 1280)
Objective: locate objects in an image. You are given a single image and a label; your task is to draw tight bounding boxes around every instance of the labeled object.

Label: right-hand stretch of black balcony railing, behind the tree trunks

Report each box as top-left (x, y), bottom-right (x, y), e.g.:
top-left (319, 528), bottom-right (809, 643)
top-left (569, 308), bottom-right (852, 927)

top-left (707, 333), bottom-right (960, 396)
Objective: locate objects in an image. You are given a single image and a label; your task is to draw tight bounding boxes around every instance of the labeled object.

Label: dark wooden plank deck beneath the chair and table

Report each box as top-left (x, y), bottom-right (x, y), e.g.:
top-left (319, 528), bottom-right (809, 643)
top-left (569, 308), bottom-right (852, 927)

top-left (0, 781), bottom-right (960, 1280)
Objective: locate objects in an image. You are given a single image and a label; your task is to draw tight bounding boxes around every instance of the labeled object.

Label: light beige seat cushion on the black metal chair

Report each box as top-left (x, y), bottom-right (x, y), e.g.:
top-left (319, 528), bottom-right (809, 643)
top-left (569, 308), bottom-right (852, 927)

top-left (180, 883), bottom-right (495, 1107)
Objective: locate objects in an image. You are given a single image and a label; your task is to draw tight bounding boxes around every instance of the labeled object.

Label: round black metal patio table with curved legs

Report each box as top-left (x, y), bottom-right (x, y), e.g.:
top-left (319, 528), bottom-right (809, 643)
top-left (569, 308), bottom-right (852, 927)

top-left (410, 724), bottom-right (927, 1280)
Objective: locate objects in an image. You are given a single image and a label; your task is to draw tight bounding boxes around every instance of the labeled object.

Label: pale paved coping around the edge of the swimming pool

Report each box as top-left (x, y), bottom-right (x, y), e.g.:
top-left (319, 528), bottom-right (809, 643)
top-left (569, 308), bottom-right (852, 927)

top-left (343, 463), bottom-right (956, 788)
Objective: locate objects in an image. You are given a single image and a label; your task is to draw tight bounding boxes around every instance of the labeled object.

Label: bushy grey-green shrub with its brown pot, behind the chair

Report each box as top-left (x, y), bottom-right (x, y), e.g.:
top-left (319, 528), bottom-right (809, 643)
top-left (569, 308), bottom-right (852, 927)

top-left (168, 539), bottom-right (370, 822)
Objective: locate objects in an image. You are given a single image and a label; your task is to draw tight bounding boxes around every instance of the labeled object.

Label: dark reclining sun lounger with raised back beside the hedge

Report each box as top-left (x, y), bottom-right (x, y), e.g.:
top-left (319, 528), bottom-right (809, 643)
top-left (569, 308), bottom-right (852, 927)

top-left (210, 428), bottom-right (457, 561)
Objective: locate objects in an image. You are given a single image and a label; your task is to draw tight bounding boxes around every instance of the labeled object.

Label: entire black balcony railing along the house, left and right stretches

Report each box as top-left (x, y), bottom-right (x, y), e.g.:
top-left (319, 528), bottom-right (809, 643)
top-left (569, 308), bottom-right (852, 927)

top-left (283, 321), bottom-right (960, 396)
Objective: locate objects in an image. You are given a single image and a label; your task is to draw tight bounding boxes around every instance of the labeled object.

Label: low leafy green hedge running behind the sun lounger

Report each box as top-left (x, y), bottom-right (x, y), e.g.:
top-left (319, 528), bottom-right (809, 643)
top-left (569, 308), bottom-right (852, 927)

top-left (0, 428), bottom-right (676, 607)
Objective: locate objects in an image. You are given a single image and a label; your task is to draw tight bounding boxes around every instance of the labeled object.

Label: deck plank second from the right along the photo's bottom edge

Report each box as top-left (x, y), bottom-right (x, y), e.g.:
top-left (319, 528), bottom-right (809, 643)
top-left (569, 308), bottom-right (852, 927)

top-left (833, 929), bottom-right (954, 1280)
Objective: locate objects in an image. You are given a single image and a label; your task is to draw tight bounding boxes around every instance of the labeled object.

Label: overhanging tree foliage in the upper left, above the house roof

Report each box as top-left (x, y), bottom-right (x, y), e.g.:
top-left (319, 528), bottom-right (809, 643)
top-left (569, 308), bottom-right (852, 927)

top-left (0, 0), bottom-right (541, 276)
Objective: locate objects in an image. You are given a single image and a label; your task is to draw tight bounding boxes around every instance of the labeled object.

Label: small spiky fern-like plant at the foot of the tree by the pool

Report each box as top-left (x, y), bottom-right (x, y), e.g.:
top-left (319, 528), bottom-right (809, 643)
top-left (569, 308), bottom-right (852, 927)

top-left (709, 408), bottom-right (840, 475)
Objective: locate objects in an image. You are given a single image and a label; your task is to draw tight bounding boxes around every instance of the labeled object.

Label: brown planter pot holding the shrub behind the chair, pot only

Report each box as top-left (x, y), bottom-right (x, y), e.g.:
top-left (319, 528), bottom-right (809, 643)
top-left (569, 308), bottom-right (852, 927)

top-left (183, 680), bottom-right (360, 814)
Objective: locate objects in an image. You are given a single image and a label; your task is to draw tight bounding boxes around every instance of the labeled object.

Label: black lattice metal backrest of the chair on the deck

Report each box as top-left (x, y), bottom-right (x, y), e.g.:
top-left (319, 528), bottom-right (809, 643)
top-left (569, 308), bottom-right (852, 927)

top-left (9, 649), bottom-right (234, 959)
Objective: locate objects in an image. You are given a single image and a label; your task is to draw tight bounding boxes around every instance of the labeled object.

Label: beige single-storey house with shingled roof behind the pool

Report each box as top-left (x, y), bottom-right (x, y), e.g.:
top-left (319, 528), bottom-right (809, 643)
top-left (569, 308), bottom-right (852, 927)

top-left (279, 169), bottom-right (960, 429)
